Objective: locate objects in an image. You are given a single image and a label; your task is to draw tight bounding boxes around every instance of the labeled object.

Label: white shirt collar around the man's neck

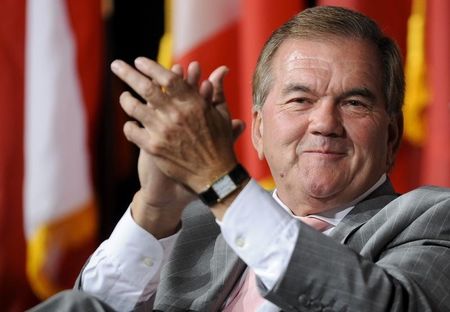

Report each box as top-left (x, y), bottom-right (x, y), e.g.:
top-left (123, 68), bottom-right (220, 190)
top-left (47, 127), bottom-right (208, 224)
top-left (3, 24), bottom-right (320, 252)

top-left (272, 173), bottom-right (386, 227)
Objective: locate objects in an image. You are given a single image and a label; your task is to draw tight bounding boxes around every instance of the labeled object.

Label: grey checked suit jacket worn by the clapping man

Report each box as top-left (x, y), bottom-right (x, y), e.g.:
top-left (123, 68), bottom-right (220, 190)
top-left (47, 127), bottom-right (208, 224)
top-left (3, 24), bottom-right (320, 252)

top-left (149, 181), bottom-right (450, 312)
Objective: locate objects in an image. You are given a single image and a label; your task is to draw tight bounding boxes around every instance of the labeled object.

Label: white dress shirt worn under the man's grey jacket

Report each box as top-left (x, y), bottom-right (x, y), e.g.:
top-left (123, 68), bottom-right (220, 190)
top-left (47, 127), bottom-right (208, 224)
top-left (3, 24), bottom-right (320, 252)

top-left (82, 175), bottom-right (386, 312)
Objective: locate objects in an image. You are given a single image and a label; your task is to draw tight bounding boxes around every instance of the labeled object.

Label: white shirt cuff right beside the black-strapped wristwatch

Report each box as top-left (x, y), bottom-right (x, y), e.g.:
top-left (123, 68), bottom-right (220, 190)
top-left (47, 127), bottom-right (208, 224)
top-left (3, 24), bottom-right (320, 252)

top-left (219, 180), bottom-right (300, 289)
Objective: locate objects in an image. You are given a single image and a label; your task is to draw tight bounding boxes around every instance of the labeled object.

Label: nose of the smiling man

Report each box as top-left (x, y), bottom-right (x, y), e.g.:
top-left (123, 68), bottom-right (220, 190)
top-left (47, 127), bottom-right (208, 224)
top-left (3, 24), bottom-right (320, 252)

top-left (309, 98), bottom-right (345, 137)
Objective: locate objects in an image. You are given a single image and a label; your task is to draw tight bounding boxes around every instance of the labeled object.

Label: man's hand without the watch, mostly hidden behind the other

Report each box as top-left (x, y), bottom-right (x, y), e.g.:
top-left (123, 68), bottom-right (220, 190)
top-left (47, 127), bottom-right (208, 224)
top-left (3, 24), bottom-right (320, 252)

top-left (125, 62), bottom-right (244, 239)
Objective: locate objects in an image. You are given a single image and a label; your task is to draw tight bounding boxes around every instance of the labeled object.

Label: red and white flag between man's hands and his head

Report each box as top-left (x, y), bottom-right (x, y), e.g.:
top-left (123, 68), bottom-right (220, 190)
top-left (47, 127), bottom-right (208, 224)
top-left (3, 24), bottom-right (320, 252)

top-left (158, 0), bottom-right (302, 188)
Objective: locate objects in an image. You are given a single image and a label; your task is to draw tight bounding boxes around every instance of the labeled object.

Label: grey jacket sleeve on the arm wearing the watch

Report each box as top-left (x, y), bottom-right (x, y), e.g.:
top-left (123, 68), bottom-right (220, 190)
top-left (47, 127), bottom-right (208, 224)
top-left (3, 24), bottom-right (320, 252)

top-left (265, 188), bottom-right (450, 312)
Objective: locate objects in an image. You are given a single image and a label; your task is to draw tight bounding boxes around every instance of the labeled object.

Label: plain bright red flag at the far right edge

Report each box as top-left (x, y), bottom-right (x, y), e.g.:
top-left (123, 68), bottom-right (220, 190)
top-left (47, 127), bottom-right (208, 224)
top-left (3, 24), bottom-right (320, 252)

top-left (421, 0), bottom-right (450, 187)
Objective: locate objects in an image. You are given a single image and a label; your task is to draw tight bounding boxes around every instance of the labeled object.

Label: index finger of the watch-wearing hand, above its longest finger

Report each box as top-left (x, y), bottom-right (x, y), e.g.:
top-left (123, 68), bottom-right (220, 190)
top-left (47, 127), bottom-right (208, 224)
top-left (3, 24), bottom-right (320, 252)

top-left (134, 57), bottom-right (188, 95)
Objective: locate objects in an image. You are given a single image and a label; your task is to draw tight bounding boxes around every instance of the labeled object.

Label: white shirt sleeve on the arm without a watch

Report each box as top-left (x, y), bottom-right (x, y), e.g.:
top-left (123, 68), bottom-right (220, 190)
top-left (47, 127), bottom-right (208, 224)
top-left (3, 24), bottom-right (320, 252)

top-left (81, 208), bottom-right (178, 311)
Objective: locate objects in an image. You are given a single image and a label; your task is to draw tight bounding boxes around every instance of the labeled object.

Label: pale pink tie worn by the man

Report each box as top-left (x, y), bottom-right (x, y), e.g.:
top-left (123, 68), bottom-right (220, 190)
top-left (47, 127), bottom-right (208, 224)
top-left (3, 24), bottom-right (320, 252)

top-left (222, 216), bottom-right (331, 312)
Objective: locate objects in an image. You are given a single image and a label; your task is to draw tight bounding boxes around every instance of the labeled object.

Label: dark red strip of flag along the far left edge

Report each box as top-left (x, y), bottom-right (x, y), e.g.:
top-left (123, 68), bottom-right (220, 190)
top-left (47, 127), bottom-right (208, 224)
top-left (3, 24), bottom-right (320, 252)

top-left (0, 0), bottom-right (37, 311)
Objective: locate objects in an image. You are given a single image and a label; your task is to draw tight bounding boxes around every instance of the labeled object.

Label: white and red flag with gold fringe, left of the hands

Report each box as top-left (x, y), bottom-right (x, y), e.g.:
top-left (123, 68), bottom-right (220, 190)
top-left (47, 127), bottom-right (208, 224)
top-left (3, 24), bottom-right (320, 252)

top-left (23, 0), bottom-right (101, 298)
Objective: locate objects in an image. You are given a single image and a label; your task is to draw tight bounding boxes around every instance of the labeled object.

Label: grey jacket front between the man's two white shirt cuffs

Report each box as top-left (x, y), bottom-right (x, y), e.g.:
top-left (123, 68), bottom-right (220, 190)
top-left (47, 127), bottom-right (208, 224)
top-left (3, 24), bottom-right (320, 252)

top-left (154, 203), bottom-right (246, 312)
